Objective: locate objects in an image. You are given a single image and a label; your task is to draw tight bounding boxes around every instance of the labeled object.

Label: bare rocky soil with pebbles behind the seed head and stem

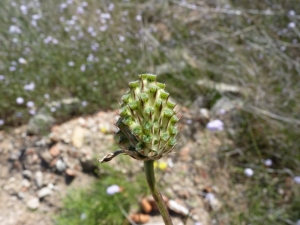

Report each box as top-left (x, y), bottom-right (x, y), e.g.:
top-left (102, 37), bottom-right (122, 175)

top-left (0, 96), bottom-right (241, 225)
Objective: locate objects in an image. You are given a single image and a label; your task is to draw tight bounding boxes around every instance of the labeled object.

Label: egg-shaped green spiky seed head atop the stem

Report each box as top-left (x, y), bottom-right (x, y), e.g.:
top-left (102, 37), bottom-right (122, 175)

top-left (116, 74), bottom-right (179, 161)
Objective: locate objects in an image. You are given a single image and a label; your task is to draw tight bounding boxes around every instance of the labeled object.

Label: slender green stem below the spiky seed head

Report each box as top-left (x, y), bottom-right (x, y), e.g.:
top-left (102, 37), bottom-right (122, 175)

top-left (144, 160), bottom-right (173, 225)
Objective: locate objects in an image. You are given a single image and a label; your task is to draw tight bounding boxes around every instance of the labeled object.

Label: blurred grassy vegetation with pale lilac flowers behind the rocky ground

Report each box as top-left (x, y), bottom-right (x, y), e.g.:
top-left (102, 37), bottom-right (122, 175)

top-left (0, 0), bottom-right (300, 224)
